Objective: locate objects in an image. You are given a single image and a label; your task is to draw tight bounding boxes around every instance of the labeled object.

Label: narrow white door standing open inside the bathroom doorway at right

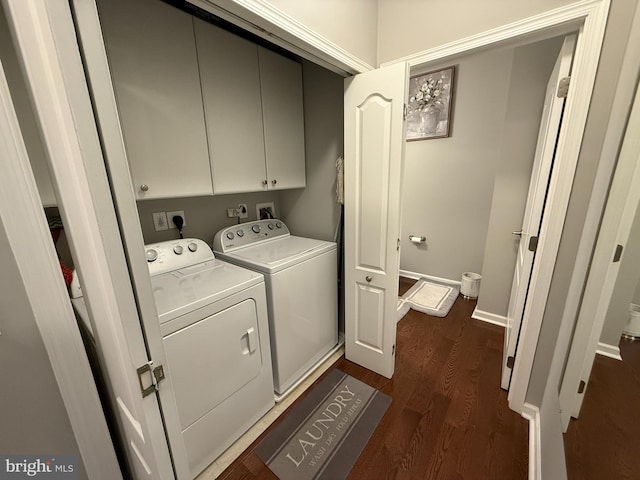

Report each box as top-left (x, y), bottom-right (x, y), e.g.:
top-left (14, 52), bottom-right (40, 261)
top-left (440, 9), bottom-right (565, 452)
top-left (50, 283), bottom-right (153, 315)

top-left (501, 35), bottom-right (576, 390)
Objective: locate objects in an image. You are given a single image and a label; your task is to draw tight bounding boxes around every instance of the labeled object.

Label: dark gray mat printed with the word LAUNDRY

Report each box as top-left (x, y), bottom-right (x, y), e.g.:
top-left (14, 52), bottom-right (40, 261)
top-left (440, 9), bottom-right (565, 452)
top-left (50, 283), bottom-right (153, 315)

top-left (255, 369), bottom-right (391, 480)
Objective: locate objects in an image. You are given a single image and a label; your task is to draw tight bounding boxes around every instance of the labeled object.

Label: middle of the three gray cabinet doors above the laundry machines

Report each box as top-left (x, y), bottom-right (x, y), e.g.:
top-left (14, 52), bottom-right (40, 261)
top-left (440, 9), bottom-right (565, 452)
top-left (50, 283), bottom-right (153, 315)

top-left (194, 18), bottom-right (267, 193)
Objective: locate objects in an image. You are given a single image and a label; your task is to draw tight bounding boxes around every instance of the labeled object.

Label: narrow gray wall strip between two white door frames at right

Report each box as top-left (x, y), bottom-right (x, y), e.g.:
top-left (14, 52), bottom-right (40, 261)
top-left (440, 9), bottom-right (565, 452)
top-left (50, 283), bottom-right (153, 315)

top-left (526, 0), bottom-right (637, 405)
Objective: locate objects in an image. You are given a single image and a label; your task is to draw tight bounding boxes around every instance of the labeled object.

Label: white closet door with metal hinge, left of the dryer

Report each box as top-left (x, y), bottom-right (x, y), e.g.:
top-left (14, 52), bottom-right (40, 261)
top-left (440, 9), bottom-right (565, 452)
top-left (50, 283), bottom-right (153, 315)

top-left (4, 0), bottom-right (178, 479)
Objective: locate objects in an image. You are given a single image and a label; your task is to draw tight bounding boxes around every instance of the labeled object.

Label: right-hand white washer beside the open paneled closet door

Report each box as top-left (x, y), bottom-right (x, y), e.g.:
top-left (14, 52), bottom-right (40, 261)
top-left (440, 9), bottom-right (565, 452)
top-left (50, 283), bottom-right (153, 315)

top-left (213, 219), bottom-right (338, 401)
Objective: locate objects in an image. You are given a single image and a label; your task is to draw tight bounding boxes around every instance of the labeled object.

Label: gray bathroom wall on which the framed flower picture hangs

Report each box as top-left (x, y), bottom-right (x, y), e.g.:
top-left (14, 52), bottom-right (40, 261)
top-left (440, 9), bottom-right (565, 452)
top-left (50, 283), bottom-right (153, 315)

top-left (400, 49), bottom-right (513, 281)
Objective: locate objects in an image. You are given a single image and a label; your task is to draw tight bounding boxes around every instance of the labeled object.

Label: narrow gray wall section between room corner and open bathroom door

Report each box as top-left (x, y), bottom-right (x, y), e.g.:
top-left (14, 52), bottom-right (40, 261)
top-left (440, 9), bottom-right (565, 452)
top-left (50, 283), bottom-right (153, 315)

top-left (477, 37), bottom-right (563, 316)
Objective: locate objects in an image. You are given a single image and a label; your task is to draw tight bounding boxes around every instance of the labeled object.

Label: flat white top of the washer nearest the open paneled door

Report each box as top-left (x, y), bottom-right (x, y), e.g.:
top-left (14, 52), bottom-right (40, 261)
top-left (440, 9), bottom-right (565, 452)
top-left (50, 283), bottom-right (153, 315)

top-left (216, 236), bottom-right (336, 274)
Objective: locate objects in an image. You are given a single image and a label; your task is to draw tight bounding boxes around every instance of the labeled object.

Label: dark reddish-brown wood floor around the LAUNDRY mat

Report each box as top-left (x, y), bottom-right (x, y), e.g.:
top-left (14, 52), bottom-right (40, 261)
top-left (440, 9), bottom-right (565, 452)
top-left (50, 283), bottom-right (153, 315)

top-left (219, 282), bottom-right (528, 480)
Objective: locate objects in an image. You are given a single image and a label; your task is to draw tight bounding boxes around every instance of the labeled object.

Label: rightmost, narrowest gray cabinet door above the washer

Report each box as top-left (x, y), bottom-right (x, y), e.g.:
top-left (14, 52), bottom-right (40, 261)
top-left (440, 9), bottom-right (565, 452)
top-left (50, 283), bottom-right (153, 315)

top-left (259, 47), bottom-right (306, 190)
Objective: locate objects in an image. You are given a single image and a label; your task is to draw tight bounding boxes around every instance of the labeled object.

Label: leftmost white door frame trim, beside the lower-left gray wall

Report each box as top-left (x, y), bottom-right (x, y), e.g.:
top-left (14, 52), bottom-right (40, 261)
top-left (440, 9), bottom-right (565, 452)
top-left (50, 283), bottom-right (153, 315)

top-left (0, 36), bottom-right (122, 479)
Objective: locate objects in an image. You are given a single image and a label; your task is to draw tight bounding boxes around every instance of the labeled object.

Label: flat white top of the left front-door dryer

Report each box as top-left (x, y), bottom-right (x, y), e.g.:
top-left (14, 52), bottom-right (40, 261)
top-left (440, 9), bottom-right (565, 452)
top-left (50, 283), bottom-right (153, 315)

top-left (151, 259), bottom-right (264, 324)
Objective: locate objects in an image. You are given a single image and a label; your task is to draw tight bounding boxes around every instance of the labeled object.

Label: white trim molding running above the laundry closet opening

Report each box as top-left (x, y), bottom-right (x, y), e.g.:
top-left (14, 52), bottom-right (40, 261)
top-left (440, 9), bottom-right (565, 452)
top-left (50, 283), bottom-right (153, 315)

top-left (187, 0), bottom-right (374, 76)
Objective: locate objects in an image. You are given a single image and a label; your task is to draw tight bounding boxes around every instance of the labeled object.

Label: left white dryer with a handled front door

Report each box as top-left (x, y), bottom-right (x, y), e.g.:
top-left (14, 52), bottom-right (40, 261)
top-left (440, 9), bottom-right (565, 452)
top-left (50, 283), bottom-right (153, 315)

top-left (145, 239), bottom-right (275, 476)
